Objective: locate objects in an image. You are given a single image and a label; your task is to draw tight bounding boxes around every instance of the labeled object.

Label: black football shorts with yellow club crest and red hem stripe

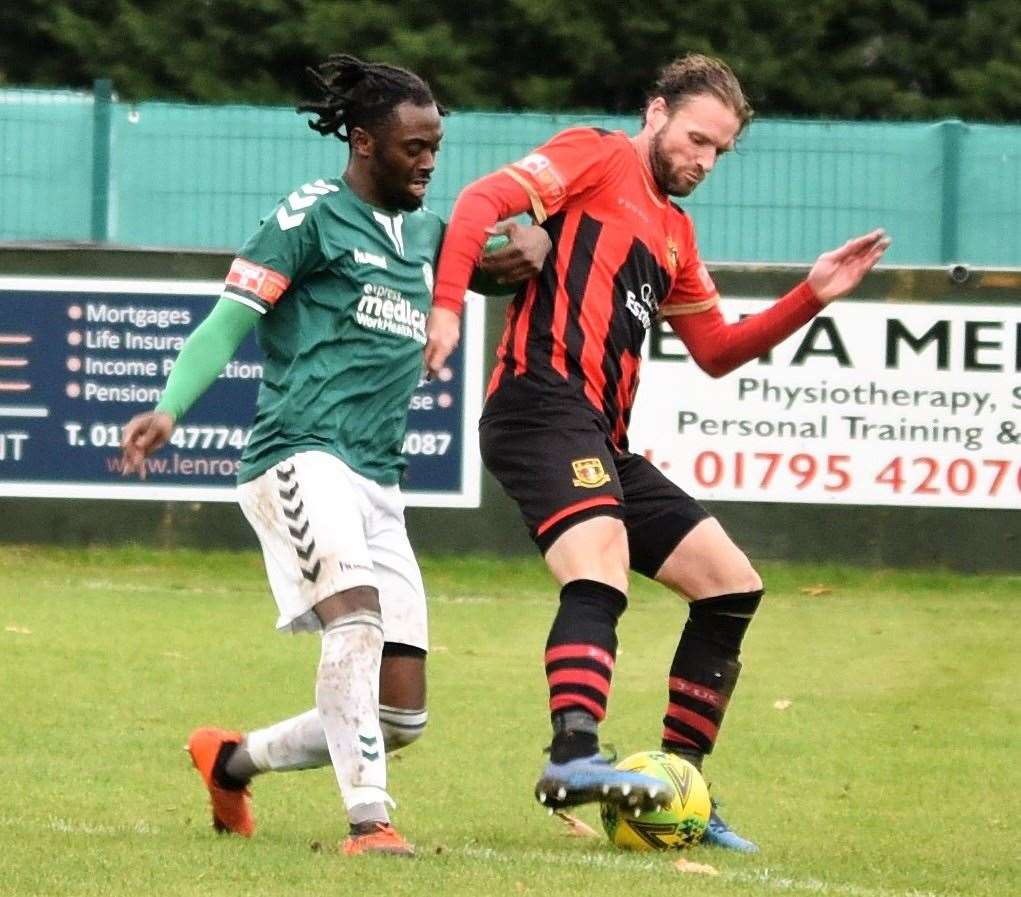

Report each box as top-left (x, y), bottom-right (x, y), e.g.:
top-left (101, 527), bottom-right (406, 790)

top-left (479, 413), bottom-right (711, 578)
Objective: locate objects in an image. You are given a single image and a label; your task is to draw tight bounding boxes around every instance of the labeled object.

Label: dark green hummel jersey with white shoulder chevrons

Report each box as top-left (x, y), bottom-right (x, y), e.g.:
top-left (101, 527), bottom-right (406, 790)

top-left (224, 179), bottom-right (443, 485)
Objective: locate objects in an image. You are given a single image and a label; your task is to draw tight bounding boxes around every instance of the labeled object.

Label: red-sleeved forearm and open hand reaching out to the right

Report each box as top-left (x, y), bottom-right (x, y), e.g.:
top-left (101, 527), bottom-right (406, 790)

top-left (668, 230), bottom-right (890, 377)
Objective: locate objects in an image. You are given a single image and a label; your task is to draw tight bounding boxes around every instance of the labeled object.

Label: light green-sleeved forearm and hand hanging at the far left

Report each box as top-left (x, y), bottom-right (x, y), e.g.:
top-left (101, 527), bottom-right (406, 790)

top-left (120, 298), bottom-right (259, 480)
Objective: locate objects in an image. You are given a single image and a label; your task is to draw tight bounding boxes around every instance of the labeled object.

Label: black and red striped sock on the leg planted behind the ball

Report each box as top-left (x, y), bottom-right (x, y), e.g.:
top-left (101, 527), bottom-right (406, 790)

top-left (663, 590), bottom-right (763, 768)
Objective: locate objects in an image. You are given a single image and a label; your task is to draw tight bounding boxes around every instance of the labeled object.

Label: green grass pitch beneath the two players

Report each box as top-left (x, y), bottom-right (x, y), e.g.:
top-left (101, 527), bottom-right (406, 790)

top-left (0, 547), bottom-right (1021, 897)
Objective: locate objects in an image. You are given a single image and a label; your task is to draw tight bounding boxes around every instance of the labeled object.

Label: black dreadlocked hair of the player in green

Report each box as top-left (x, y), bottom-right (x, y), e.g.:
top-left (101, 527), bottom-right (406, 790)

top-left (297, 53), bottom-right (446, 143)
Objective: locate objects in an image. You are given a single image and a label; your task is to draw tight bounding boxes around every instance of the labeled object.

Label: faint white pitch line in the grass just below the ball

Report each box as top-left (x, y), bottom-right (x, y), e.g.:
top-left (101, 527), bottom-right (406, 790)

top-left (450, 847), bottom-right (958, 897)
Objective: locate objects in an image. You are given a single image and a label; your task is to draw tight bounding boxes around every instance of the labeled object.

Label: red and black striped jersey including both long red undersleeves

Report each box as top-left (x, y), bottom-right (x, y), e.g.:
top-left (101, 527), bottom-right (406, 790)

top-left (433, 128), bottom-right (823, 451)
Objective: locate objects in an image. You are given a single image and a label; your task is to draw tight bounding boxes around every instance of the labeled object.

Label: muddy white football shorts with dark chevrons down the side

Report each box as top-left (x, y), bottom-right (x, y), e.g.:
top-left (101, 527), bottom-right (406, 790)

top-left (238, 451), bottom-right (429, 650)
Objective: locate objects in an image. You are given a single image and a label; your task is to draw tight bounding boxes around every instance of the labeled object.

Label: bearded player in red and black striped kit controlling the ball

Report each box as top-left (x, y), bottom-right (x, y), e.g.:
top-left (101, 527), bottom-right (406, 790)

top-left (426, 55), bottom-right (889, 851)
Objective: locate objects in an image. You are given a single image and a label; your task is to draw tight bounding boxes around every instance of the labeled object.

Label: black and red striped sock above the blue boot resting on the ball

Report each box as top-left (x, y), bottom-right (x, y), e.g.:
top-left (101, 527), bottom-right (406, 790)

top-left (545, 580), bottom-right (628, 763)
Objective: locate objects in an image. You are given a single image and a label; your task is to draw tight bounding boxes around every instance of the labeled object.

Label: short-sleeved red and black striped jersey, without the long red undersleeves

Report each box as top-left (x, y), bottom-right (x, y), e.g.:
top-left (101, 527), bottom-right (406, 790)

top-left (479, 128), bottom-right (718, 450)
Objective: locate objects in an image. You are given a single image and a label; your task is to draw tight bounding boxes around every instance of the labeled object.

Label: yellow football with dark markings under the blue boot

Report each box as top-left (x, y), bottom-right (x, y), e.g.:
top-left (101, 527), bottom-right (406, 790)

top-left (599, 751), bottom-right (711, 850)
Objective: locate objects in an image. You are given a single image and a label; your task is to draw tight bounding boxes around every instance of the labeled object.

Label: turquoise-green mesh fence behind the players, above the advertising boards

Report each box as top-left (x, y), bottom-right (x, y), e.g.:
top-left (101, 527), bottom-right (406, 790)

top-left (0, 82), bottom-right (1021, 266)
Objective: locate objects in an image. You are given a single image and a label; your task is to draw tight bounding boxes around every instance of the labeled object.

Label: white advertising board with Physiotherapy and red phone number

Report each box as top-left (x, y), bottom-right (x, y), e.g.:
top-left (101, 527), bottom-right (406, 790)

top-left (630, 299), bottom-right (1021, 509)
